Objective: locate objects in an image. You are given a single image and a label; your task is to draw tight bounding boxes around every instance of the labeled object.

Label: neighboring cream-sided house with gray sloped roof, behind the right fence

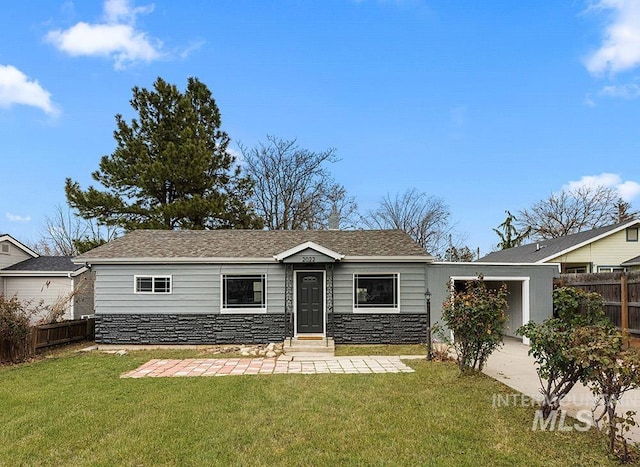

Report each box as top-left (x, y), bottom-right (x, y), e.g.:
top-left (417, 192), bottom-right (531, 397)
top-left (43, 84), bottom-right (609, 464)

top-left (478, 220), bottom-right (640, 274)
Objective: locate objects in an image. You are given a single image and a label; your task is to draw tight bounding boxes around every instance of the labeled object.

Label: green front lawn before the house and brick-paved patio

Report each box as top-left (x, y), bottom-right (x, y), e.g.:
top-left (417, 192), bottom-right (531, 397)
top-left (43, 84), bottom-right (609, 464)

top-left (0, 351), bottom-right (616, 466)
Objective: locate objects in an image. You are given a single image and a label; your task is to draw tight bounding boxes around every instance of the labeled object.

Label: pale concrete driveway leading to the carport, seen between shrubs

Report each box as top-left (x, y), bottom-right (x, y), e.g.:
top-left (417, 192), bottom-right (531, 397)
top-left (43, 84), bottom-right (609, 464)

top-left (483, 338), bottom-right (640, 442)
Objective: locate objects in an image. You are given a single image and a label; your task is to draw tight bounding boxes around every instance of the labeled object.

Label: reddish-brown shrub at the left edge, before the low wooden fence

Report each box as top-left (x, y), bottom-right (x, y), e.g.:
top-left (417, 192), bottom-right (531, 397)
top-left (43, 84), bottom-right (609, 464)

top-left (0, 295), bottom-right (33, 363)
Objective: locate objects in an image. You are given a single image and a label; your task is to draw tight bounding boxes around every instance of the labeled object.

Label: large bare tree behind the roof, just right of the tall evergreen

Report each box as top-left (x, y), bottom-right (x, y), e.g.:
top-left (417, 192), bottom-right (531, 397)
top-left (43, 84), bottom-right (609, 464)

top-left (240, 136), bottom-right (357, 230)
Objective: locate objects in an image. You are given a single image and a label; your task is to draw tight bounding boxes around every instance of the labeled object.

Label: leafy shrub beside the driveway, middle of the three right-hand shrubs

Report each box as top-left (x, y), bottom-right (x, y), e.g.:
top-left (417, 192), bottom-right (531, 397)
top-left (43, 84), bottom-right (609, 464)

top-left (517, 287), bottom-right (608, 419)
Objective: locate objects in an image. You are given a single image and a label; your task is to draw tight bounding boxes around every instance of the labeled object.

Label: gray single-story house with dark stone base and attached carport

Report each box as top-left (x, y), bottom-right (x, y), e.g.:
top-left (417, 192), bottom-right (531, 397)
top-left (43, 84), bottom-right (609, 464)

top-left (74, 230), bottom-right (557, 344)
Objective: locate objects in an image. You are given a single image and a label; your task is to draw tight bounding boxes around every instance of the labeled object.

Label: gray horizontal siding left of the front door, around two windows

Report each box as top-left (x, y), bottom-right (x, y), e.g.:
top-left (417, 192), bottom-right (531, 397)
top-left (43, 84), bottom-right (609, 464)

top-left (94, 264), bottom-right (284, 315)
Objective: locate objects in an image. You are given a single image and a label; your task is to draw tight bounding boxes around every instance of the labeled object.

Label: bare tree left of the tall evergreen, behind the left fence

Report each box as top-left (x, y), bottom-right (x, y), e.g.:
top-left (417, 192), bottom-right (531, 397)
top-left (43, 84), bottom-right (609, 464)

top-left (31, 205), bottom-right (118, 256)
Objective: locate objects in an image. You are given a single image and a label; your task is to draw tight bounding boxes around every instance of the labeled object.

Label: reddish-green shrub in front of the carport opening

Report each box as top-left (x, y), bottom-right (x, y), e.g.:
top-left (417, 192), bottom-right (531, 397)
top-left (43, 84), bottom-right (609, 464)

top-left (442, 276), bottom-right (507, 373)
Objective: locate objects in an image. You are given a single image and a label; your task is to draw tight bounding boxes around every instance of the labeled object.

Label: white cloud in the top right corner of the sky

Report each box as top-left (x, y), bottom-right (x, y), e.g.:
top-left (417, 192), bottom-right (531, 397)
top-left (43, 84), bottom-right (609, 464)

top-left (585, 0), bottom-right (640, 75)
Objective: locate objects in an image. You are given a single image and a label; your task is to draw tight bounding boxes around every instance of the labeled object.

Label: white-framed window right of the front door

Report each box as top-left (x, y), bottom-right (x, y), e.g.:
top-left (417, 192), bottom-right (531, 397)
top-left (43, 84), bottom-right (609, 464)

top-left (353, 274), bottom-right (398, 309)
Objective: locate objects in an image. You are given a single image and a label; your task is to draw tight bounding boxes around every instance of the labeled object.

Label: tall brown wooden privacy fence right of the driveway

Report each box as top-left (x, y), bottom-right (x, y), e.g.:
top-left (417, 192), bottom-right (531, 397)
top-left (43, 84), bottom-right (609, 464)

top-left (556, 272), bottom-right (640, 334)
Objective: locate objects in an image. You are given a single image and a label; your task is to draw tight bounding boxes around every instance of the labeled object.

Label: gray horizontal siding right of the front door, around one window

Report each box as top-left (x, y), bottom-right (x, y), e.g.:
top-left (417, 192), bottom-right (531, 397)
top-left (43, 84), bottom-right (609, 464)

top-left (333, 263), bottom-right (425, 313)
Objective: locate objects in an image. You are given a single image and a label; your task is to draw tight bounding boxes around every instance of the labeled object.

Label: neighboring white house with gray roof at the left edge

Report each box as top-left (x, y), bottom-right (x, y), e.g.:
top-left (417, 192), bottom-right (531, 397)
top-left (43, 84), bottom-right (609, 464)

top-left (0, 235), bottom-right (93, 321)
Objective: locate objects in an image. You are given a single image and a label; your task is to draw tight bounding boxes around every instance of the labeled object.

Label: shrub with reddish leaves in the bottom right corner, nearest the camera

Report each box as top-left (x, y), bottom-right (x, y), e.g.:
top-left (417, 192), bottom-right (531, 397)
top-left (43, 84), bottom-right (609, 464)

top-left (568, 325), bottom-right (640, 462)
